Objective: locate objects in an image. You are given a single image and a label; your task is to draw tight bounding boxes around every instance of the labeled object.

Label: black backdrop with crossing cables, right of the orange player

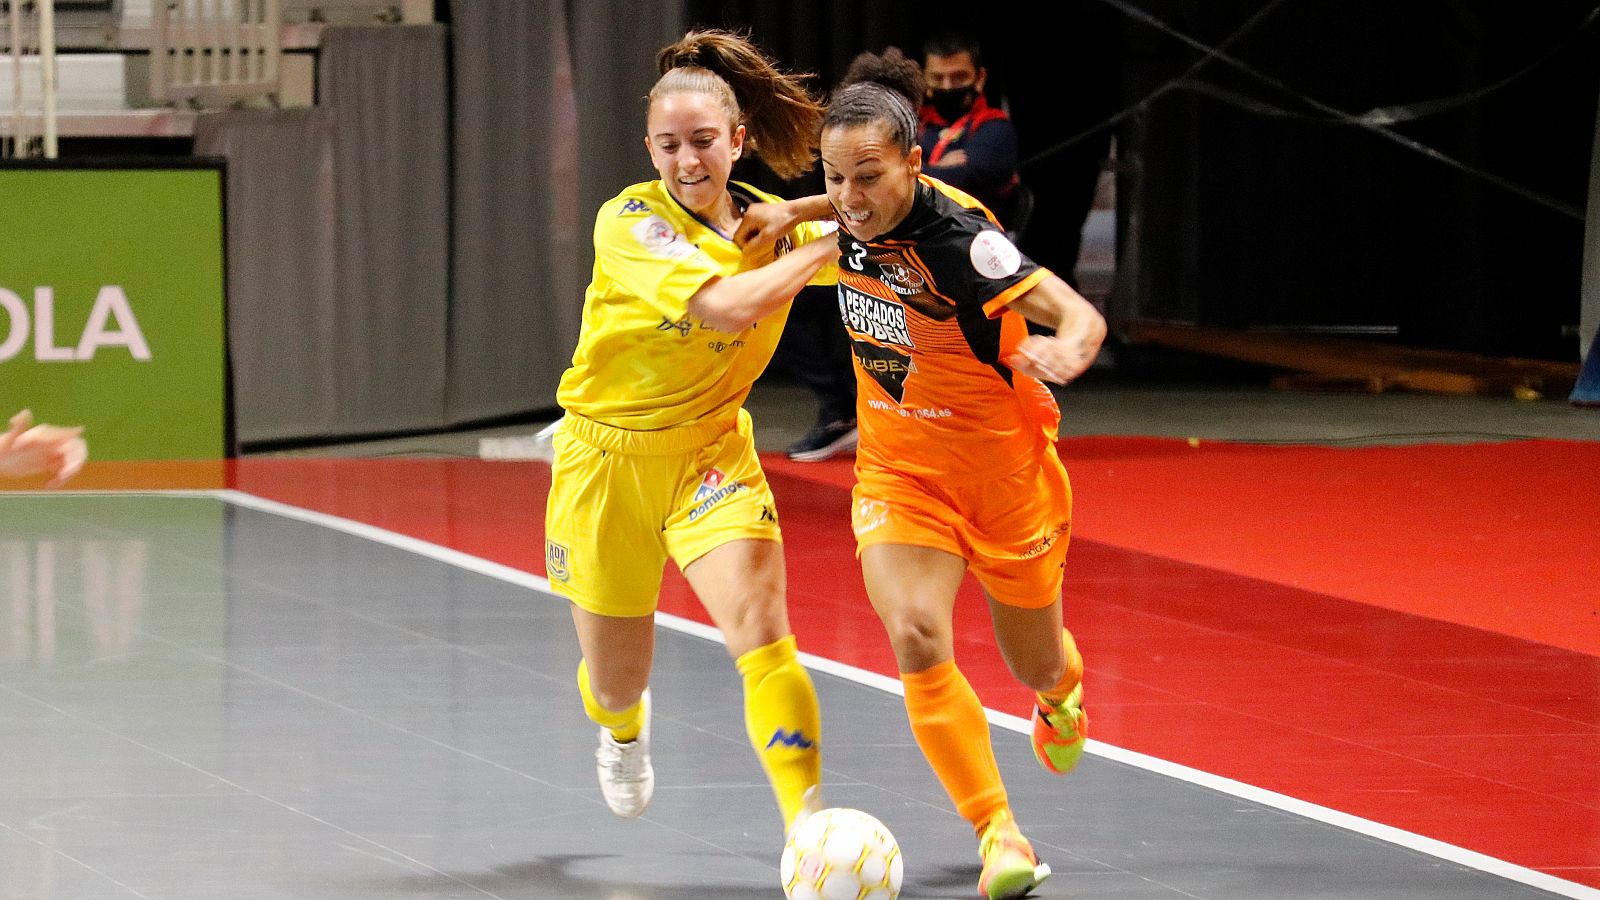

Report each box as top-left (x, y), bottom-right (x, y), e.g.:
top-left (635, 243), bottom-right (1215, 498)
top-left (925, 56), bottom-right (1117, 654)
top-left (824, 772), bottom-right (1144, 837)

top-left (1117, 0), bottom-right (1600, 360)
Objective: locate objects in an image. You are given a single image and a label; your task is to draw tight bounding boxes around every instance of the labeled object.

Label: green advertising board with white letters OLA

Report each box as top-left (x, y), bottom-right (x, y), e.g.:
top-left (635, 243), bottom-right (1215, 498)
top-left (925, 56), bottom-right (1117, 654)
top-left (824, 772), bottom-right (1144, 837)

top-left (0, 160), bottom-right (229, 460)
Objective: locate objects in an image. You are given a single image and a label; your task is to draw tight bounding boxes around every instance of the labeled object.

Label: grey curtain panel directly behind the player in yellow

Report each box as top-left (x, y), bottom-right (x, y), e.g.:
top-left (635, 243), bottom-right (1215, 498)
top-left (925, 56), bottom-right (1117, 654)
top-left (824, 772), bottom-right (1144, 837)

top-left (448, 0), bottom-right (683, 424)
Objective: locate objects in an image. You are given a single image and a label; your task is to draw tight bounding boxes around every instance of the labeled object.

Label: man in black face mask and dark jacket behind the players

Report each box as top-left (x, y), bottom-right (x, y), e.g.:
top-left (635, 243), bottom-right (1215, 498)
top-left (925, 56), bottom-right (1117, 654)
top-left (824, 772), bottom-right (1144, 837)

top-left (917, 32), bottom-right (1018, 229)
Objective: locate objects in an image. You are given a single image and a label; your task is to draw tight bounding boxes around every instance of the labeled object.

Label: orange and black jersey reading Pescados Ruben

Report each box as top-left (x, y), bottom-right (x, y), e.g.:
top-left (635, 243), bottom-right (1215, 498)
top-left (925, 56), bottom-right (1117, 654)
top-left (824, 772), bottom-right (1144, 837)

top-left (838, 176), bottom-right (1061, 482)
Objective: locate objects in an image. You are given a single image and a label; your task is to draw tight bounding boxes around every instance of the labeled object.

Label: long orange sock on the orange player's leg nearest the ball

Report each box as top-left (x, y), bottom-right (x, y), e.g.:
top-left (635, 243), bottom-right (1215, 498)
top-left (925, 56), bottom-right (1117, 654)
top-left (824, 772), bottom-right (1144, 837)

top-left (901, 660), bottom-right (1008, 828)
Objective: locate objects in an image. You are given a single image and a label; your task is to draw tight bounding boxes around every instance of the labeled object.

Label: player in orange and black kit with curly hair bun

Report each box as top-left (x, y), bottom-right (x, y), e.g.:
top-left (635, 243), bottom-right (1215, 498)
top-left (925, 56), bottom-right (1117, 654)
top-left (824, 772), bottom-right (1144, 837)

top-left (745, 48), bottom-right (1106, 900)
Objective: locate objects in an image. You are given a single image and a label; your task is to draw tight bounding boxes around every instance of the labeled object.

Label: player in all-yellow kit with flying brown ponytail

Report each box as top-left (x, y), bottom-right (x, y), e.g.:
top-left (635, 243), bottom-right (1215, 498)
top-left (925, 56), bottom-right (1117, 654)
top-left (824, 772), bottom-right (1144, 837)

top-left (546, 30), bottom-right (838, 830)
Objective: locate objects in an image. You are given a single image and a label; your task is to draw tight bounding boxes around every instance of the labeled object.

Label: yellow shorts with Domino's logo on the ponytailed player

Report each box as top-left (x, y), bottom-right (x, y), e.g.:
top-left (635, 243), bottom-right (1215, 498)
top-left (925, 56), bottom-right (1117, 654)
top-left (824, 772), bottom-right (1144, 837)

top-left (544, 410), bottom-right (782, 617)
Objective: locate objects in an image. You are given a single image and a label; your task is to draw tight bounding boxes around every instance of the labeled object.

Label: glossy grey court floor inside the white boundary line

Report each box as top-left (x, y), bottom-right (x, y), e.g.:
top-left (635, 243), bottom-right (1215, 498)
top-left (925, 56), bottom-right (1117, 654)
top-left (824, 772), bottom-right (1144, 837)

top-left (0, 470), bottom-right (1587, 900)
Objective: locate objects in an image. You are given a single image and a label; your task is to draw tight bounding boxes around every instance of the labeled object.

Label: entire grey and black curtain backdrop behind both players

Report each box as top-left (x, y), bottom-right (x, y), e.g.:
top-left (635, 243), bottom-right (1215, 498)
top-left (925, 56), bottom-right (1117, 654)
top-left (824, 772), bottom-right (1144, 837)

top-left (206, 0), bottom-right (1600, 444)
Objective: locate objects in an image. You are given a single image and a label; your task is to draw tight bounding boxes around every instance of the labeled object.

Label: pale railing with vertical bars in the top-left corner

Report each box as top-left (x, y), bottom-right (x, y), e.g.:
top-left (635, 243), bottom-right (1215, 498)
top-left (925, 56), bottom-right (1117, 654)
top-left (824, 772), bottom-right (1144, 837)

top-left (0, 0), bottom-right (58, 160)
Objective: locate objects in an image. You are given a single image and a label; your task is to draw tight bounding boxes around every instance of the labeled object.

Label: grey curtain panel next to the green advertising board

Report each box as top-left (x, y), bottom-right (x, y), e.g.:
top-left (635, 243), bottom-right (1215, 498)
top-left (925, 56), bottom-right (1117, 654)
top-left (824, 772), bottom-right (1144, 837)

top-left (195, 26), bottom-right (450, 445)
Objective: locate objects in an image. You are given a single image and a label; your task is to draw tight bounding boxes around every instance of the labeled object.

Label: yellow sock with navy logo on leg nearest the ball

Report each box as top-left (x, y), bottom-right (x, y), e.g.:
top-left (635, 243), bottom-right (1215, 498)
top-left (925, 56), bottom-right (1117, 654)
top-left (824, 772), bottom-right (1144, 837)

top-left (734, 634), bottom-right (822, 831)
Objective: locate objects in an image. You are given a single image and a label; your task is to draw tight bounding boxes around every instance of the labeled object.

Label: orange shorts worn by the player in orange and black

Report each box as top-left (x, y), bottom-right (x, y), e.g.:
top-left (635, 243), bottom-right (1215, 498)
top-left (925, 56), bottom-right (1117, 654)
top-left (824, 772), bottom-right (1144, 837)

top-left (851, 445), bottom-right (1072, 609)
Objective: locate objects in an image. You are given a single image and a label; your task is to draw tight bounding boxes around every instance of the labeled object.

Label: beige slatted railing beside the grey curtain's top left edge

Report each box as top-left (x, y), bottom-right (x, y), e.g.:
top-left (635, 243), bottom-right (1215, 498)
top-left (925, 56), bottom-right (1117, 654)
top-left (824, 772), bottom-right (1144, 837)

top-left (150, 0), bottom-right (283, 106)
